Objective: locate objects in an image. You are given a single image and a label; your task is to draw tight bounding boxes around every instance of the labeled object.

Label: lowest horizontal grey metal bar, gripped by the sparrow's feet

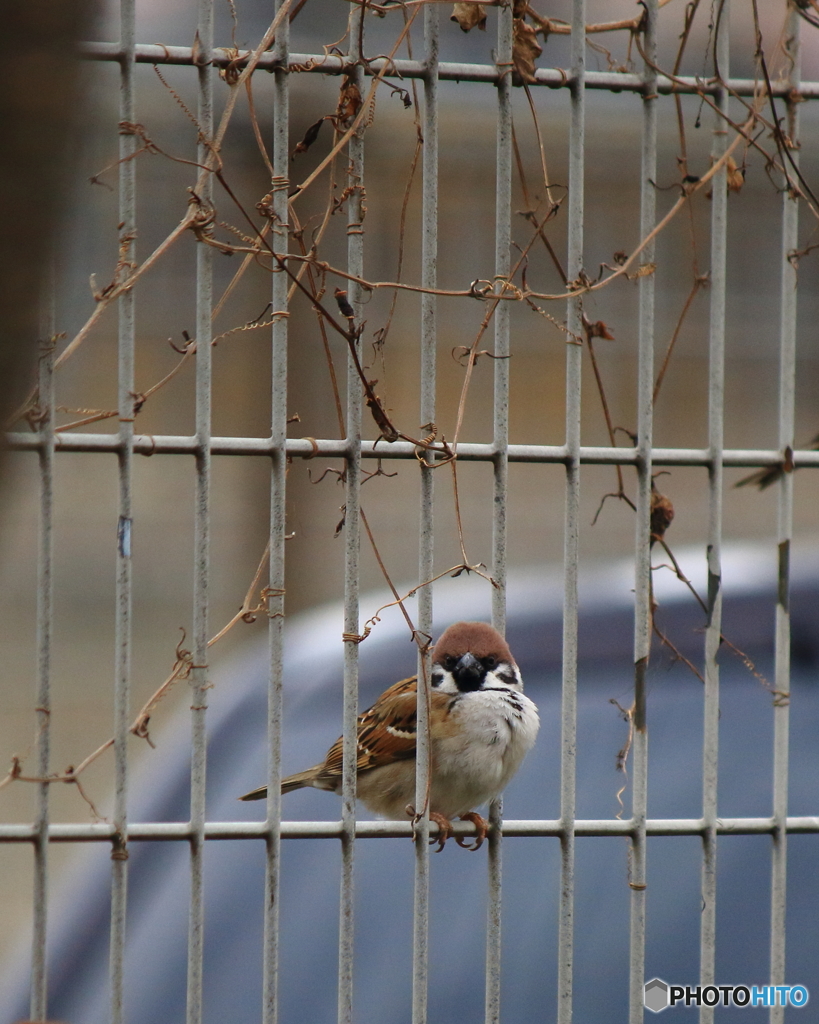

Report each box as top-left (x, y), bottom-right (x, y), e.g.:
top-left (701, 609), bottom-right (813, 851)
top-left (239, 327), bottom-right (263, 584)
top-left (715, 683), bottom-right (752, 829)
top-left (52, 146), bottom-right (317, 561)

top-left (0, 817), bottom-right (819, 843)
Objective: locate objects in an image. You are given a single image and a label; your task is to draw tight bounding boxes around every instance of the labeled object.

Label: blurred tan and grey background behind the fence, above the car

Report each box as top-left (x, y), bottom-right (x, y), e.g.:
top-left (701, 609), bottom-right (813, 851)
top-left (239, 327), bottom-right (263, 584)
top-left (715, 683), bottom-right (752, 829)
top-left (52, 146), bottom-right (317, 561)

top-left (0, 0), bottom-right (819, 995)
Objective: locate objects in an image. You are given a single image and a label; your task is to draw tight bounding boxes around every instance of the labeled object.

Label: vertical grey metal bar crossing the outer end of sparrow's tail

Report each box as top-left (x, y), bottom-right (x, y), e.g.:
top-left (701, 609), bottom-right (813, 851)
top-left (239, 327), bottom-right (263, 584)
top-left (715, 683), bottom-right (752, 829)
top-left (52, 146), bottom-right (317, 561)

top-left (262, 0), bottom-right (290, 1024)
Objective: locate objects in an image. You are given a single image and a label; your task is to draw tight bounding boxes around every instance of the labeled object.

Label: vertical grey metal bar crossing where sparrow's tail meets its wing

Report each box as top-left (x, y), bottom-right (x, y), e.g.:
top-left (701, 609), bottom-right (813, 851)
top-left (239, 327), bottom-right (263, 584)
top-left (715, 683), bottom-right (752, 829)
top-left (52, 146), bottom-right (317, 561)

top-left (338, 6), bottom-right (364, 1024)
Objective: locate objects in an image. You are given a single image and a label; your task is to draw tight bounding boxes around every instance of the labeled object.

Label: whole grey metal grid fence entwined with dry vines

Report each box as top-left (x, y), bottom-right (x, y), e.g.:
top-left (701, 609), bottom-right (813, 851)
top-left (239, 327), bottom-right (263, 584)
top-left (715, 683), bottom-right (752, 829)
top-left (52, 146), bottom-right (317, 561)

top-left (0, 0), bottom-right (819, 1024)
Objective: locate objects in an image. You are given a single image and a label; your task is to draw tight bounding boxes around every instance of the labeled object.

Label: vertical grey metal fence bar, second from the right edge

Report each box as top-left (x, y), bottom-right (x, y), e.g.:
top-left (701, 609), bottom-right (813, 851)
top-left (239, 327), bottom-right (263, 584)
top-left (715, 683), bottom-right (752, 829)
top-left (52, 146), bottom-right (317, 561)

top-left (699, 6), bottom-right (731, 1024)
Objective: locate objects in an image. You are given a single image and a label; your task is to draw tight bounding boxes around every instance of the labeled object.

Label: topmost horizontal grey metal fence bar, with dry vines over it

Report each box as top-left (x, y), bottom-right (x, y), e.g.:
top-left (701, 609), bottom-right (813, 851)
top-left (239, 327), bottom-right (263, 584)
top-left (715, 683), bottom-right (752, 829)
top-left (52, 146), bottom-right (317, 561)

top-left (80, 43), bottom-right (819, 99)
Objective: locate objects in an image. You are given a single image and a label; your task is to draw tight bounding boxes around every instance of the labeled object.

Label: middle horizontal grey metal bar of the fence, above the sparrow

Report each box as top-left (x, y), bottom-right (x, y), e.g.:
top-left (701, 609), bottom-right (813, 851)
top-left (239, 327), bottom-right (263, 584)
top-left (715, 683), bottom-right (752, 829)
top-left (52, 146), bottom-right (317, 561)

top-left (5, 433), bottom-right (819, 469)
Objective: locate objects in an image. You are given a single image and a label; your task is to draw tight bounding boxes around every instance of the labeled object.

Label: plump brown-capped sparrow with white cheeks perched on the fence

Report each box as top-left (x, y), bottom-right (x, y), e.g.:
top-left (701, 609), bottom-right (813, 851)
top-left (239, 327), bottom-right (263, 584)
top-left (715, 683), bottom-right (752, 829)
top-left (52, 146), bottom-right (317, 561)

top-left (239, 623), bottom-right (541, 850)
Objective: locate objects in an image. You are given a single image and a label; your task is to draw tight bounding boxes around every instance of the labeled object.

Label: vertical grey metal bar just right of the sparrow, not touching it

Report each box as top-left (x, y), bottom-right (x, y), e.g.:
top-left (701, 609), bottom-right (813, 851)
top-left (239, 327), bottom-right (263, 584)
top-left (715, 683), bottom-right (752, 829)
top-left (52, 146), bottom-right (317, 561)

top-left (557, 0), bottom-right (586, 1024)
